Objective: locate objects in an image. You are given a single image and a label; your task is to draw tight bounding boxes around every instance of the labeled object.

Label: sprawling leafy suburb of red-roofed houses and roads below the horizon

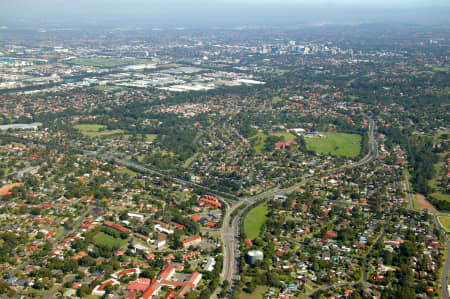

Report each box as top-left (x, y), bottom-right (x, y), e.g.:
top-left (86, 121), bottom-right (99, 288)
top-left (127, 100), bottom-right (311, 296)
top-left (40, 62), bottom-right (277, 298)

top-left (0, 21), bottom-right (450, 299)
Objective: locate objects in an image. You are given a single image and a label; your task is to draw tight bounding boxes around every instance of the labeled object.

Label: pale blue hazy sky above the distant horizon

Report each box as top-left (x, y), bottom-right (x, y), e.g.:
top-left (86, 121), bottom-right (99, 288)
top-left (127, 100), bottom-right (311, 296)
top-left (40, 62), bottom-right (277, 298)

top-left (0, 0), bottom-right (450, 27)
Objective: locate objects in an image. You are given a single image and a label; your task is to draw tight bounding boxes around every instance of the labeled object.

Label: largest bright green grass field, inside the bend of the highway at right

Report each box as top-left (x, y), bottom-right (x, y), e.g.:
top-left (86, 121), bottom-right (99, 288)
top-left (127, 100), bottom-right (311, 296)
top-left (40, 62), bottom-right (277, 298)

top-left (305, 133), bottom-right (361, 158)
